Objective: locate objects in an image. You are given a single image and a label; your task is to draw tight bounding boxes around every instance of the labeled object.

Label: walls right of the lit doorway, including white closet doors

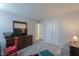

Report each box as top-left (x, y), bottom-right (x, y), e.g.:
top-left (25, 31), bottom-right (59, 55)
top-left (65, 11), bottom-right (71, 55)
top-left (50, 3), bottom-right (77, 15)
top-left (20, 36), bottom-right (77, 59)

top-left (41, 11), bottom-right (79, 55)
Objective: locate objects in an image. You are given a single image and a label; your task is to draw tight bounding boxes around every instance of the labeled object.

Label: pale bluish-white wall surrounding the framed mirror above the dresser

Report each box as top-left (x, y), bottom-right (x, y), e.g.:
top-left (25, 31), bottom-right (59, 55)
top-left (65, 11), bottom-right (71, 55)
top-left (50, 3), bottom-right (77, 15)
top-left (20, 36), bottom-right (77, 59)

top-left (0, 10), bottom-right (35, 55)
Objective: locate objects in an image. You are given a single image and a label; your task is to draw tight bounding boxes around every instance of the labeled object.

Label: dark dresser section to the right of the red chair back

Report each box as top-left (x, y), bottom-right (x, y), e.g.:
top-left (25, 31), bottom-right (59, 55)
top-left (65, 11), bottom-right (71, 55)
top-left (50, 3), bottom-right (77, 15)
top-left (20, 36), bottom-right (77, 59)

top-left (18, 35), bottom-right (33, 50)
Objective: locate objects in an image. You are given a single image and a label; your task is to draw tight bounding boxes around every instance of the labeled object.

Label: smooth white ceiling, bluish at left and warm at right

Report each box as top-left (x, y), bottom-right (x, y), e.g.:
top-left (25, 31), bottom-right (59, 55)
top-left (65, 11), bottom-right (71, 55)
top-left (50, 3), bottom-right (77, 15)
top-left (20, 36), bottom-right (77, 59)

top-left (0, 3), bottom-right (79, 20)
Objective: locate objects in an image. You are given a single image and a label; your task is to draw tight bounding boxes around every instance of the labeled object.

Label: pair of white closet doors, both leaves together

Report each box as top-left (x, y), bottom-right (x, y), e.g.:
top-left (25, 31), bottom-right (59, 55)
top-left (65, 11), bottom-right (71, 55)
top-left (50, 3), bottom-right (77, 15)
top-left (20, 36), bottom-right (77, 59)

top-left (46, 19), bottom-right (60, 45)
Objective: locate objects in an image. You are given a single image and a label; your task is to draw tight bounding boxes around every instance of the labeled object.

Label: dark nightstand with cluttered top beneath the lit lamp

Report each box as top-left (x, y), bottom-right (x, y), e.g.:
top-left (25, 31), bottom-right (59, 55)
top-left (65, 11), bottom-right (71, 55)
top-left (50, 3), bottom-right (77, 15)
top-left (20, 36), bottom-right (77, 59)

top-left (69, 37), bottom-right (79, 56)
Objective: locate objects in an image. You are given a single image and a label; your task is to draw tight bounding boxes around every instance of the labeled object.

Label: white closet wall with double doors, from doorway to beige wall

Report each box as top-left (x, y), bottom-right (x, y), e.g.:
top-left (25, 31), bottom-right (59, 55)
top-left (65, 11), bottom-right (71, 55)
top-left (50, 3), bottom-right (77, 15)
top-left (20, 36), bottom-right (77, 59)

top-left (41, 19), bottom-right (60, 45)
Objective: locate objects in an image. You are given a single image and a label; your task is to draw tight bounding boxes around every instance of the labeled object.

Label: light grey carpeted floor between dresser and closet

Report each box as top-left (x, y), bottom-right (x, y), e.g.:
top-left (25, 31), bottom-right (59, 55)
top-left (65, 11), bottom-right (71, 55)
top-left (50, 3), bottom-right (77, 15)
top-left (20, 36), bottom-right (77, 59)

top-left (18, 41), bottom-right (68, 56)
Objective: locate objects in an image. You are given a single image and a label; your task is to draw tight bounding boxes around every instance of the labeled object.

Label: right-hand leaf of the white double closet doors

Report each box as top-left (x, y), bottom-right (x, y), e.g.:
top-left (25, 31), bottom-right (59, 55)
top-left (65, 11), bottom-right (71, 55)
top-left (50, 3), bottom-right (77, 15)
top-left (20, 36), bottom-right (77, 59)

top-left (52, 20), bottom-right (60, 45)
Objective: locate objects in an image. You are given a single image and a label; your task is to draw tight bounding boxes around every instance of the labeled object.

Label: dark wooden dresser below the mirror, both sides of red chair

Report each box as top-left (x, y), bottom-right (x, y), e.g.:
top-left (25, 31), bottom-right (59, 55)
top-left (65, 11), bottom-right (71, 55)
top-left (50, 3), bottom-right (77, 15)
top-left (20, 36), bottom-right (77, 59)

top-left (6, 35), bottom-right (33, 50)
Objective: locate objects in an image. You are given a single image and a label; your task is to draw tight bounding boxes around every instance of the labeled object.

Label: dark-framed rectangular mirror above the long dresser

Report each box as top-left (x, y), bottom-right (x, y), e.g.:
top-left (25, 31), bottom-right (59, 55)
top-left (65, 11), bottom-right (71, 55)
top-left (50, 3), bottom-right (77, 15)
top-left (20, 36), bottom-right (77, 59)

top-left (13, 21), bottom-right (27, 36)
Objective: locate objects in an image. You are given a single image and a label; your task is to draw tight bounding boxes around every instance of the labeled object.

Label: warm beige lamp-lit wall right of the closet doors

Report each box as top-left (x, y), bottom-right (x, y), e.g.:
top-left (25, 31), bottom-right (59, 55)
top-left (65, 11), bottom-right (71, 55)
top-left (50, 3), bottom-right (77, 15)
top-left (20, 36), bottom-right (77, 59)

top-left (58, 11), bottom-right (79, 48)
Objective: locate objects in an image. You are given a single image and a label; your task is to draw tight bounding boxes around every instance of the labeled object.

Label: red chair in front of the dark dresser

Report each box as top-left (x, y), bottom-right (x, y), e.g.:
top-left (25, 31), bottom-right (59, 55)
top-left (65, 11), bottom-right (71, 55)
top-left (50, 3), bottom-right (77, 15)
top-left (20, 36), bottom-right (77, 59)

top-left (4, 37), bottom-right (19, 56)
